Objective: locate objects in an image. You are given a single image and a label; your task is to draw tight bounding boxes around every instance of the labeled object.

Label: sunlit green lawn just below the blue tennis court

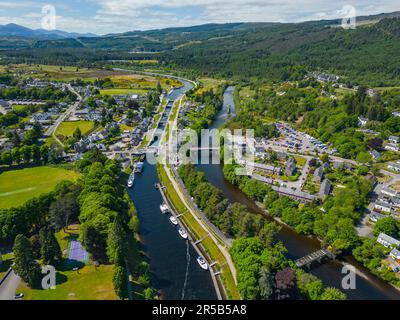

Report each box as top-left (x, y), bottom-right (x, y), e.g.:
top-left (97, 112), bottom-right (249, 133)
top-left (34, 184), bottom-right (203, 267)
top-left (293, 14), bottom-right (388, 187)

top-left (17, 265), bottom-right (117, 300)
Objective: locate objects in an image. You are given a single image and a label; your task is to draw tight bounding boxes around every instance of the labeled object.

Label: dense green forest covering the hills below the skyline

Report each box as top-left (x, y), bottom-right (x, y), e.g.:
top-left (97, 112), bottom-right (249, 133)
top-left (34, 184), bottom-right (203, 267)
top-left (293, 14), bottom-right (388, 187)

top-left (2, 17), bottom-right (400, 86)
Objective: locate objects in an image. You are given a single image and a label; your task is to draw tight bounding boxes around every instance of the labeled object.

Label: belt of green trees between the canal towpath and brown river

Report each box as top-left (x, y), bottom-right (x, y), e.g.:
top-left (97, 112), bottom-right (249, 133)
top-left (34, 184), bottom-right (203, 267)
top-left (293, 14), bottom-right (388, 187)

top-left (178, 164), bottom-right (346, 300)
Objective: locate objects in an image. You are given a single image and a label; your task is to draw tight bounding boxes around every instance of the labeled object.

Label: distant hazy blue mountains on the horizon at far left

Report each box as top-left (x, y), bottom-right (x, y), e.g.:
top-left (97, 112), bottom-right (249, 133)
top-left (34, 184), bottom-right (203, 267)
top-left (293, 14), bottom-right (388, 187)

top-left (0, 23), bottom-right (97, 40)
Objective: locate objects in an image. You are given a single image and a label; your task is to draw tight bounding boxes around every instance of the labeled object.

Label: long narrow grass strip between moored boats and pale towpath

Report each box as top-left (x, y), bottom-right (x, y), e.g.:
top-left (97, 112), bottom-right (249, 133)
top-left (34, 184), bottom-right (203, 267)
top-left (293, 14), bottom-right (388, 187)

top-left (158, 166), bottom-right (240, 300)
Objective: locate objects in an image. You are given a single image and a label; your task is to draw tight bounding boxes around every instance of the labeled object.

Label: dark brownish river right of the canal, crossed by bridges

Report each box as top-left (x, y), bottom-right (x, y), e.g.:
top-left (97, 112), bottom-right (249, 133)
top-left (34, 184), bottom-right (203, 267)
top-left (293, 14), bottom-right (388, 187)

top-left (198, 87), bottom-right (400, 300)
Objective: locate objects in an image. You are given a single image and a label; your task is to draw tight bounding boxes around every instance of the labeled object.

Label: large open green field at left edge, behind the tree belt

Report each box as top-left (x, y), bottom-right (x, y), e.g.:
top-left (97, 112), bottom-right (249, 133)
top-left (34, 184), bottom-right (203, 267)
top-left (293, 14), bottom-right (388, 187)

top-left (0, 167), bottom-right (79, 209)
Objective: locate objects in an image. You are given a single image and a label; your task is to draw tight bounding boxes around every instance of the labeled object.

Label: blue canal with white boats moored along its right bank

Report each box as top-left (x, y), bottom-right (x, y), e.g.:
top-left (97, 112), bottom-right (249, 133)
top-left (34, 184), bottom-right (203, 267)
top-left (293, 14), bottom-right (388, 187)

top-left (129, 81), bottom-right (217, 300)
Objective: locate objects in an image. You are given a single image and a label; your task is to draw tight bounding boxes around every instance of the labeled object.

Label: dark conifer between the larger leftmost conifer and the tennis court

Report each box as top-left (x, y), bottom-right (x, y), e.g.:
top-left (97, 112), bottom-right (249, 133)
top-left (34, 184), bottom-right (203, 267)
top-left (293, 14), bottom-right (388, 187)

top-left (39, 228), bottom-right (62, 266)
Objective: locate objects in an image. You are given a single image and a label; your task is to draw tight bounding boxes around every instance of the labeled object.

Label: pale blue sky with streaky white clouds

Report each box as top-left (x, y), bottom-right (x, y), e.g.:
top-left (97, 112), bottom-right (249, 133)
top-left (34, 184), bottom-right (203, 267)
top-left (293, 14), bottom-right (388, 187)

top-left (0, 0), bottom-right (400, 35)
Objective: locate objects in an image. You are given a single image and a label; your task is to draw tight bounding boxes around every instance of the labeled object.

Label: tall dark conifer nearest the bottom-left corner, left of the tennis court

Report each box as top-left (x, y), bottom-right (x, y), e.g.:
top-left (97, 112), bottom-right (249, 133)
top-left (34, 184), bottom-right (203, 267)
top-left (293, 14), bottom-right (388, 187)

top-left (13, 234), bottom-right (41, 288)
